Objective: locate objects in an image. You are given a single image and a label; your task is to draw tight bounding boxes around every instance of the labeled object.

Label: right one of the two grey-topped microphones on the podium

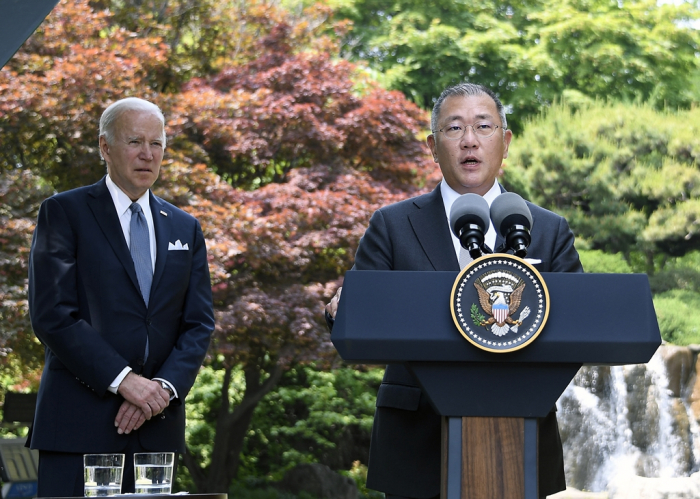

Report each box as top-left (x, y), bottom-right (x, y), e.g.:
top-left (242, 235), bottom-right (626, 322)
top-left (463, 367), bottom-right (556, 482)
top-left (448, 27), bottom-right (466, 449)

top-left (491, 192), bottom-right (532, 258)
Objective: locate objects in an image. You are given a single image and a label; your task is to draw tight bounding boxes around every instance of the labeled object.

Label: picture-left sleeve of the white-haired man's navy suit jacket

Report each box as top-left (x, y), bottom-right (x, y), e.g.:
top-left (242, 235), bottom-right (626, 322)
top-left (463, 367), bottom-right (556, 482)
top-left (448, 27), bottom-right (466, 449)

top-left (28, 198), bottom-right (128, 395)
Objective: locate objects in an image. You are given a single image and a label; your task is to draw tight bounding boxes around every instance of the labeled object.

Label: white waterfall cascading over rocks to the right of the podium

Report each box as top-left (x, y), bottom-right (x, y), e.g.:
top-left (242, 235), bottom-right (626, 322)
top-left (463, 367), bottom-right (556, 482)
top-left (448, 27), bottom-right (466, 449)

top-left (557, 352), bottom-right (700, 492)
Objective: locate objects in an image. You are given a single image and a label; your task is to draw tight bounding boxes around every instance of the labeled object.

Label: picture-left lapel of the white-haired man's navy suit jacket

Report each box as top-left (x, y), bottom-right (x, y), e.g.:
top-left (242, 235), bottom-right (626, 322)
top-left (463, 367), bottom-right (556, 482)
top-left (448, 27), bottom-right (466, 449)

top-left (87, 177), bottom-right (141, 294)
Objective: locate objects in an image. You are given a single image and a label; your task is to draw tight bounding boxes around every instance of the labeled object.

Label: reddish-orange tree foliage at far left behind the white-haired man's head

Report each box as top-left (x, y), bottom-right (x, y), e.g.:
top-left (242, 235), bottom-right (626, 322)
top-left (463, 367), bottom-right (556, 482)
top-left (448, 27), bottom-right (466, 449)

top-left (0, 1), bottom-right (167, 191)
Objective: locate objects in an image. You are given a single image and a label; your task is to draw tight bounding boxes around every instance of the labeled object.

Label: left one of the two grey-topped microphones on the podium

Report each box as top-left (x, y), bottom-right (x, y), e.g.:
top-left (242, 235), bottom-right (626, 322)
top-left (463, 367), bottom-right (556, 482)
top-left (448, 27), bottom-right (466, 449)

top-left (450, 193), bottom-right (491, 260)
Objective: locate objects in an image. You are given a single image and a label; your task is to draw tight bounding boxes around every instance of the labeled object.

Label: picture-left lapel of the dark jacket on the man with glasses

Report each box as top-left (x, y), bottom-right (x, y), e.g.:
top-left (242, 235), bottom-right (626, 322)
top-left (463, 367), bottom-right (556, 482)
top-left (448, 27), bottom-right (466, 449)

top-left (408, 186), bottom-right (459, 271)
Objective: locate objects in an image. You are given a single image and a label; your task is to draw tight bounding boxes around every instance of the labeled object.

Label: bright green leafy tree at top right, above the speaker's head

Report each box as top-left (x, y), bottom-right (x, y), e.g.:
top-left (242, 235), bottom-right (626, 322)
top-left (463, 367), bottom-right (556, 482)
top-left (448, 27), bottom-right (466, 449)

top-left (337, 0), bottom-right (698, 132)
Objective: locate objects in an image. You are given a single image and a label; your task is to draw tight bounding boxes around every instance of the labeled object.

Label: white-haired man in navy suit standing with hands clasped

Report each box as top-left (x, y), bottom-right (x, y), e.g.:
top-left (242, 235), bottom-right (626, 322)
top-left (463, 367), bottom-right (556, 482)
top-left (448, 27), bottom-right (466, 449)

top-left (28, 98), bottom-right (214, 497)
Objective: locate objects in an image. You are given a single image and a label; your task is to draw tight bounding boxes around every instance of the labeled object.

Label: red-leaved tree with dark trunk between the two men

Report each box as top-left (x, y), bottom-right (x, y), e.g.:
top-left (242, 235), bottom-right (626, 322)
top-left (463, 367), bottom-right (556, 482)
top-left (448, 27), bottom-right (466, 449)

top-left (168, 20), bottom-right (434, 492)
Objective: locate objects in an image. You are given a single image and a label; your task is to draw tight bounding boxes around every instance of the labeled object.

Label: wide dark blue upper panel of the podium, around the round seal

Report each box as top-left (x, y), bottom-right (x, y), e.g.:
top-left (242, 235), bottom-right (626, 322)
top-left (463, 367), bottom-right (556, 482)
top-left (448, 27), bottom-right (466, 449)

top-left (331, 271), bottom-right (661, 365)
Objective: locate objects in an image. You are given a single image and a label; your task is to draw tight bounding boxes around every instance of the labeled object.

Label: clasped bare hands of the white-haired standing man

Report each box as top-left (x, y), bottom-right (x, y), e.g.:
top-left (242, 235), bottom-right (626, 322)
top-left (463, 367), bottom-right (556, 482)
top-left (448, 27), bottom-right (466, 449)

top-left (114, 372), bottom-right (170, 435)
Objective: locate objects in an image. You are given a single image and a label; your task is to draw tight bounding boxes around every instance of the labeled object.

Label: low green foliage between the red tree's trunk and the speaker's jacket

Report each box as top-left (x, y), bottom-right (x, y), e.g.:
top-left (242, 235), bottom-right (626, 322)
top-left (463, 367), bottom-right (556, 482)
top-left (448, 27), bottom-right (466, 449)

top-left (242, 367), bottom-right (383, 478)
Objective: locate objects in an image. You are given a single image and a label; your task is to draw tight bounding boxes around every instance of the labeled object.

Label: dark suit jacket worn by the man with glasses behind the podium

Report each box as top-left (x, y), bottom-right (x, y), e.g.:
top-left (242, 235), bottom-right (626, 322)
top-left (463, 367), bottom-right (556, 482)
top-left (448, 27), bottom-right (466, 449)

top-left (355, 187), bottom-right (583, 497)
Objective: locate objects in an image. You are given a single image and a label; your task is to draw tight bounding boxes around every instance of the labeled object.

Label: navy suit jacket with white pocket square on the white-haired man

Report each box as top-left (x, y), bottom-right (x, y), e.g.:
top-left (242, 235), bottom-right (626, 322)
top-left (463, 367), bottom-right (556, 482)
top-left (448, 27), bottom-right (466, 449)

top-left (28, 178), bottom-right (214, 453)
